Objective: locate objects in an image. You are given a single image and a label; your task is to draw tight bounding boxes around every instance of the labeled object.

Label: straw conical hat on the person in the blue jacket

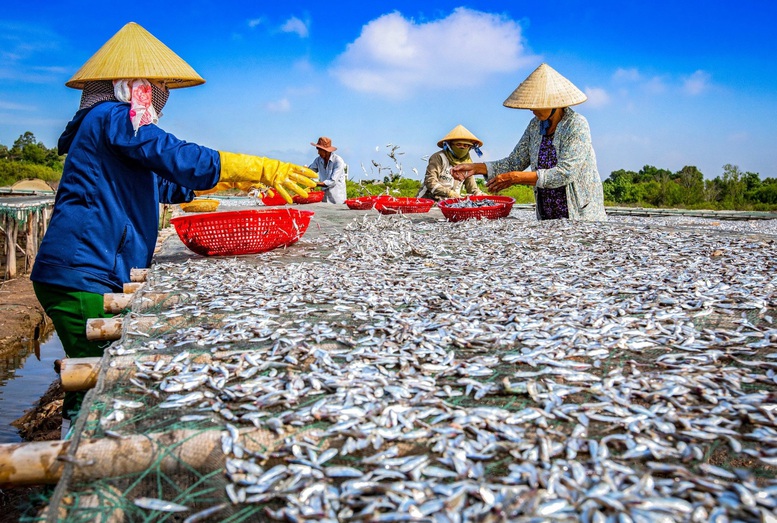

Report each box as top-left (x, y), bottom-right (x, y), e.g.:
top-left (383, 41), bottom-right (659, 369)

top-left (65, 22), bottom-right (205, 89)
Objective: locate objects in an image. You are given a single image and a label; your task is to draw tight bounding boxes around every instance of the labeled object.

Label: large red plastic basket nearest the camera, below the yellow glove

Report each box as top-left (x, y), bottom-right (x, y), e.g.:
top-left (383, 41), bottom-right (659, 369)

top-left (170, 209), bottom-right (314, 256)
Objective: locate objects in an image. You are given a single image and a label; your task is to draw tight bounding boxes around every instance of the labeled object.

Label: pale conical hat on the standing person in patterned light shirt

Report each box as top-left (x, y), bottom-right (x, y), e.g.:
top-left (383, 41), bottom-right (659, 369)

top-left (504, 64), bottom-right (588, 109)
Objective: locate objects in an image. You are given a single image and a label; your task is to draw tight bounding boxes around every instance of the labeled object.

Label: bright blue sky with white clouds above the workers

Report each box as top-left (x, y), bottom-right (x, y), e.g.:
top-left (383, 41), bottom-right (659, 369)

top-left (0, 0), bottom-right (777, 180)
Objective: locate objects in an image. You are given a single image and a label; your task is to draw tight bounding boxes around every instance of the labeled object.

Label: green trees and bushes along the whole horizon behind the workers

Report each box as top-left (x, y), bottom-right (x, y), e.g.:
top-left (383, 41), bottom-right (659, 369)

top-left (0, 131), bottom-right (777, 211)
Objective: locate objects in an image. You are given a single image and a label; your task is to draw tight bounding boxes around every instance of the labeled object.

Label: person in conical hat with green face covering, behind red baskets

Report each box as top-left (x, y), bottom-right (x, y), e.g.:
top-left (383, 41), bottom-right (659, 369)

top-left (416, 125), bottom-right (483, 201)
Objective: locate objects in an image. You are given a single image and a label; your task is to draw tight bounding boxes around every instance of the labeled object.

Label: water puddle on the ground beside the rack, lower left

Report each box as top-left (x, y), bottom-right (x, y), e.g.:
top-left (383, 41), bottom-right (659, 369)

top-left (0, 327), bottom-right (65, 443)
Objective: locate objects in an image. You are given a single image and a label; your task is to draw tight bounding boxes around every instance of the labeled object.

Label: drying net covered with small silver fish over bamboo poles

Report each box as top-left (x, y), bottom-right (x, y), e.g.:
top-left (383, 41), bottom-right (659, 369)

top-left (34, 211), bottom-right (777, 523)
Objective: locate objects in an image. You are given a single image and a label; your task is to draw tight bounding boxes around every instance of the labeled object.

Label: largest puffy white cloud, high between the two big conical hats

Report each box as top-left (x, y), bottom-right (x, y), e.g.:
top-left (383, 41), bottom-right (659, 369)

top-left (331, 7), bottom-right (533, 97)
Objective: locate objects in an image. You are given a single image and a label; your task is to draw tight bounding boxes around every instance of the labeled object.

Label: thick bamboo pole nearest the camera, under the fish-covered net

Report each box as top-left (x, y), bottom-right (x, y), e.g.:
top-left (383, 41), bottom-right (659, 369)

top-left (0, 428), bottom-right (283, 488)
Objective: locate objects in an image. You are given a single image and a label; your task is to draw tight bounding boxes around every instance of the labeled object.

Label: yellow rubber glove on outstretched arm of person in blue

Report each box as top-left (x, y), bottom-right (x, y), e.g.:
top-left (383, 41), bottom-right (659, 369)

top-left (217, 151), bottom-right (318, 203)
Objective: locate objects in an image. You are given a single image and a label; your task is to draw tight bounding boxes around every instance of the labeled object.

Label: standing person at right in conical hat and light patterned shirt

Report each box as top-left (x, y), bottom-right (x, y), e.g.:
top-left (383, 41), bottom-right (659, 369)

top-left (452, 64), bottom-right (607, 221)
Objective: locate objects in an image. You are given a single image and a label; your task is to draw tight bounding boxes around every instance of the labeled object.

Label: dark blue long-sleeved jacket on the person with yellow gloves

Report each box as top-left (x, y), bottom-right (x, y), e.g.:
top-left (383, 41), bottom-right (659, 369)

top-left (30, 102), bottom-right (221, 293)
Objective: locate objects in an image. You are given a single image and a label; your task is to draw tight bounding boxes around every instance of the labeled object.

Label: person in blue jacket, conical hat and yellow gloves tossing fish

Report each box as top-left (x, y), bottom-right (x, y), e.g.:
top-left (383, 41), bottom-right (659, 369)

top-left (30, 23), bottom-right (316, 428)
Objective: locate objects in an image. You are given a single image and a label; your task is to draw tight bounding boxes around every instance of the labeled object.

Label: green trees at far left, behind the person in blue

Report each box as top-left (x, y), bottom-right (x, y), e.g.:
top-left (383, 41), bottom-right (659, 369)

top-left (0, 131), bottom-right (65, 187)
